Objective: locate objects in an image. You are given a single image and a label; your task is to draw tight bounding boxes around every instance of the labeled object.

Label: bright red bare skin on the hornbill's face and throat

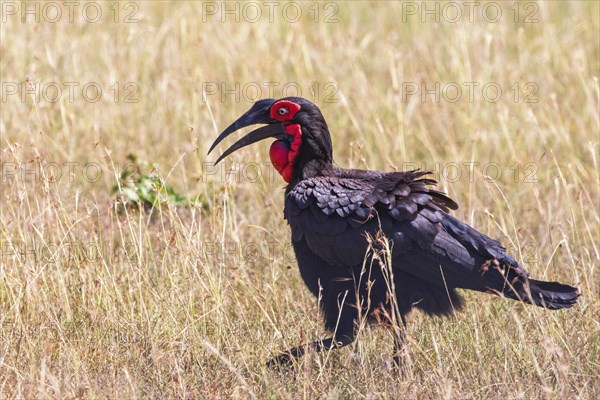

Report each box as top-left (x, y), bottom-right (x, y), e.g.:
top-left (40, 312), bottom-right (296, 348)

top-left (269, 100), bottom-right (302, 183)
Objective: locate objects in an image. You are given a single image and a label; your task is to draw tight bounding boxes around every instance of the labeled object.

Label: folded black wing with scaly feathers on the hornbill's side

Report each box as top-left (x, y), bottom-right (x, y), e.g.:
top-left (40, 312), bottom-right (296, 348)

top-left (285, 170), bottom-right (527, 290)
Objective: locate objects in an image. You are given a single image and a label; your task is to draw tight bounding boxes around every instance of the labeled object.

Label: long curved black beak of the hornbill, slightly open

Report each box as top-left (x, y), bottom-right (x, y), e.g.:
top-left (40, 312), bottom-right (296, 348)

top-left (208, 99), bottom-right (285, 165)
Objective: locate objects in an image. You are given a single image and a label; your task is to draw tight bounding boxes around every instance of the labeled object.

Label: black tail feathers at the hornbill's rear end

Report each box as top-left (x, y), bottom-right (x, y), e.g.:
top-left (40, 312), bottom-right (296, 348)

top-left (504, 279), bottom-right (581, 310)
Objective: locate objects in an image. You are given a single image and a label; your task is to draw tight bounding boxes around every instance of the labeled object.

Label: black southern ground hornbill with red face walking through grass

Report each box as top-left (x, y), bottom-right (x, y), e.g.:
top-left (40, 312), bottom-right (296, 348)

top-left (209, 97), bottom-right (579, 366)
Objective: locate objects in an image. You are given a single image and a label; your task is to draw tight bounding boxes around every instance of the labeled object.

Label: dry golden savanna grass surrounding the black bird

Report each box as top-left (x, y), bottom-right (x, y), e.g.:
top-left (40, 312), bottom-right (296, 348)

top-left (0, 1), bottom-right (600, 399)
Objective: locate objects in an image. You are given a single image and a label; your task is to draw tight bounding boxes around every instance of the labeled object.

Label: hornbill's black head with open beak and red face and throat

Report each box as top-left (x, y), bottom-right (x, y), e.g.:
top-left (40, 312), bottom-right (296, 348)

top-left (208, 97), bottom-right (332, 182)
